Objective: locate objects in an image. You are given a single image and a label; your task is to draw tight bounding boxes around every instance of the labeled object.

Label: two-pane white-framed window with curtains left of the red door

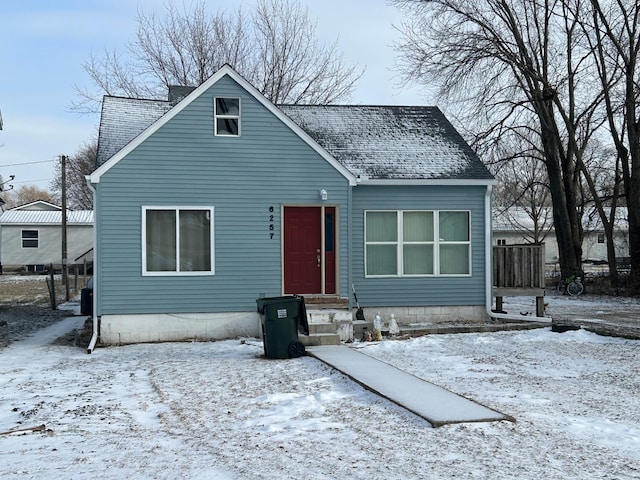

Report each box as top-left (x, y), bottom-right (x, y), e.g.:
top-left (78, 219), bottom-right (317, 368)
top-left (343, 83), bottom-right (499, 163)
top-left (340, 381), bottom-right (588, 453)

top-left (142, 206), bottom-right (215, 275)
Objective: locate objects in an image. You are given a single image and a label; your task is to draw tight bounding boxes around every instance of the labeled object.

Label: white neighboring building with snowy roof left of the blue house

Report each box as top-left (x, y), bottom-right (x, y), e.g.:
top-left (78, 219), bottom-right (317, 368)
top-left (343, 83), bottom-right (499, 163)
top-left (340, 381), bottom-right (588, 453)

top-left (0, 201), bottom-right (93, 271)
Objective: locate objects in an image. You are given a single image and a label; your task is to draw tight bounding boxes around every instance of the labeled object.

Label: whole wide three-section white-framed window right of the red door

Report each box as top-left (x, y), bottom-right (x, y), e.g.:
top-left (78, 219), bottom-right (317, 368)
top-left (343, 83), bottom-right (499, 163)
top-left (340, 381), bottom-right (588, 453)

top-left (365, 210), bottom-right (471, 277)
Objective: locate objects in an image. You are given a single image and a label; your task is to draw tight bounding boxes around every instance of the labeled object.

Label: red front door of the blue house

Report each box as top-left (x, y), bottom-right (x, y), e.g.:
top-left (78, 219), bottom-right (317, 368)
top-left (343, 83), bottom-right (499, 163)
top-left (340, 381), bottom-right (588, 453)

top-left (284, 207), bottom-right (322, 294)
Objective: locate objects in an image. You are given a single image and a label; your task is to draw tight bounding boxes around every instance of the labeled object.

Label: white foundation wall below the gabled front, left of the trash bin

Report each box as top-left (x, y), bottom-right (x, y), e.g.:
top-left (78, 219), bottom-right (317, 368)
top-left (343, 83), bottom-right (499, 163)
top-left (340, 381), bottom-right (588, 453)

top-left (99, 312), bottom-right (261, 345)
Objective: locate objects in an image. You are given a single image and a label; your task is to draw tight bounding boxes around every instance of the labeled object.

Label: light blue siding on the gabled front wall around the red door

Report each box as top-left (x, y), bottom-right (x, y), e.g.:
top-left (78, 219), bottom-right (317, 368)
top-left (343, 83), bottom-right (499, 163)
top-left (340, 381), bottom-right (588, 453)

top-left (96, 77), bottom-right (349, 315)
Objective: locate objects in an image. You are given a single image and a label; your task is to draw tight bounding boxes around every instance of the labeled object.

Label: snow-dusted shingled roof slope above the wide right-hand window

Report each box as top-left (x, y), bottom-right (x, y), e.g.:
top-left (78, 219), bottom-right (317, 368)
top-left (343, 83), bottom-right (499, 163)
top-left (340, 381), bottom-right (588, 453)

top-left (280, 105), bottom-right (493, 180)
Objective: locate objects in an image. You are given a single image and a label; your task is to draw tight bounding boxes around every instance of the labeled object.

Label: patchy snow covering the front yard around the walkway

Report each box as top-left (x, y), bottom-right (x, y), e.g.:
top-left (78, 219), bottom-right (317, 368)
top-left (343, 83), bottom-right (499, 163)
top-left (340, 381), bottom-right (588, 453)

top-left (0, 297), bottom-right (640, 480)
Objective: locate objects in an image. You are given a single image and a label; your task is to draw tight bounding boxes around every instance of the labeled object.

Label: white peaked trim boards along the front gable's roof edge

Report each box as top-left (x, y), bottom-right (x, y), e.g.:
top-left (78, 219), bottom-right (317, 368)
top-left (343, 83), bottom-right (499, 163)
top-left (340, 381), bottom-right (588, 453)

top-left (87, 65), bottom-right (356, 185)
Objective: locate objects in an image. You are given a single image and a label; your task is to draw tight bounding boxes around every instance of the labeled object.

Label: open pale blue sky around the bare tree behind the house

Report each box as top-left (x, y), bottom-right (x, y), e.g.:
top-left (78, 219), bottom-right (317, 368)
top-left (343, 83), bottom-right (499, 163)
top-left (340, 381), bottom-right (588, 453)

top-left (0, 0), bottom-right (433, 188)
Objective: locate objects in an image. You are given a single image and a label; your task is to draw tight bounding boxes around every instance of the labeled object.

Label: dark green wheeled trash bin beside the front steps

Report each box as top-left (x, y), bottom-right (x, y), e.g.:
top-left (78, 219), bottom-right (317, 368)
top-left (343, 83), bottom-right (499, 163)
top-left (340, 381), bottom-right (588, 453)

top-left (256, 295), bottom-right (309, 358)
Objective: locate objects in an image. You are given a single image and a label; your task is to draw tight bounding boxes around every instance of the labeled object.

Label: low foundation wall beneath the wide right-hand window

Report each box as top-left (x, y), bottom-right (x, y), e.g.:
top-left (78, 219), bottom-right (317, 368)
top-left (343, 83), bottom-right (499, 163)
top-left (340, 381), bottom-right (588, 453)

top-left (353, 305), bottom-right (489, 324)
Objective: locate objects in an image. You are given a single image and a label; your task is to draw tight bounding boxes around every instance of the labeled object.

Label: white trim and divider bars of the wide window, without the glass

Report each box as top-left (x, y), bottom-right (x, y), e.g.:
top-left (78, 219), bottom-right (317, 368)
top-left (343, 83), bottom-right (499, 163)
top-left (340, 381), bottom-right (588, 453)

top-left (364, 209), bottom-right (473, 278)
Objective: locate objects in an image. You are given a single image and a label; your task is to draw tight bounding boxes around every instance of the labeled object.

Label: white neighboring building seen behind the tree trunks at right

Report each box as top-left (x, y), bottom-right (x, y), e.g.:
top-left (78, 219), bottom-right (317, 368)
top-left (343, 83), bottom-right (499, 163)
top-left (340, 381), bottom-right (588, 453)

top-left (492, 207), bottom-right (629, 263)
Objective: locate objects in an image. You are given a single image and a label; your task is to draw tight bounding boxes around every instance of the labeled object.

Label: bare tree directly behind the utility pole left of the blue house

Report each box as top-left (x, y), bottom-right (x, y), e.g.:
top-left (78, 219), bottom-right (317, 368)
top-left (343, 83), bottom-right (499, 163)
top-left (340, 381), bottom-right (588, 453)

top-left (51, 138), bottom-right (98, 210)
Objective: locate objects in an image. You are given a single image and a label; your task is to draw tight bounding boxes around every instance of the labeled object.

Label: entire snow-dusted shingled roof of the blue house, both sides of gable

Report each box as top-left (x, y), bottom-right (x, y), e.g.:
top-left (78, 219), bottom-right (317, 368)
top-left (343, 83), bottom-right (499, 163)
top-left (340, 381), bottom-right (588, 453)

top-left (98, 97), bottom-right (493, 180)
